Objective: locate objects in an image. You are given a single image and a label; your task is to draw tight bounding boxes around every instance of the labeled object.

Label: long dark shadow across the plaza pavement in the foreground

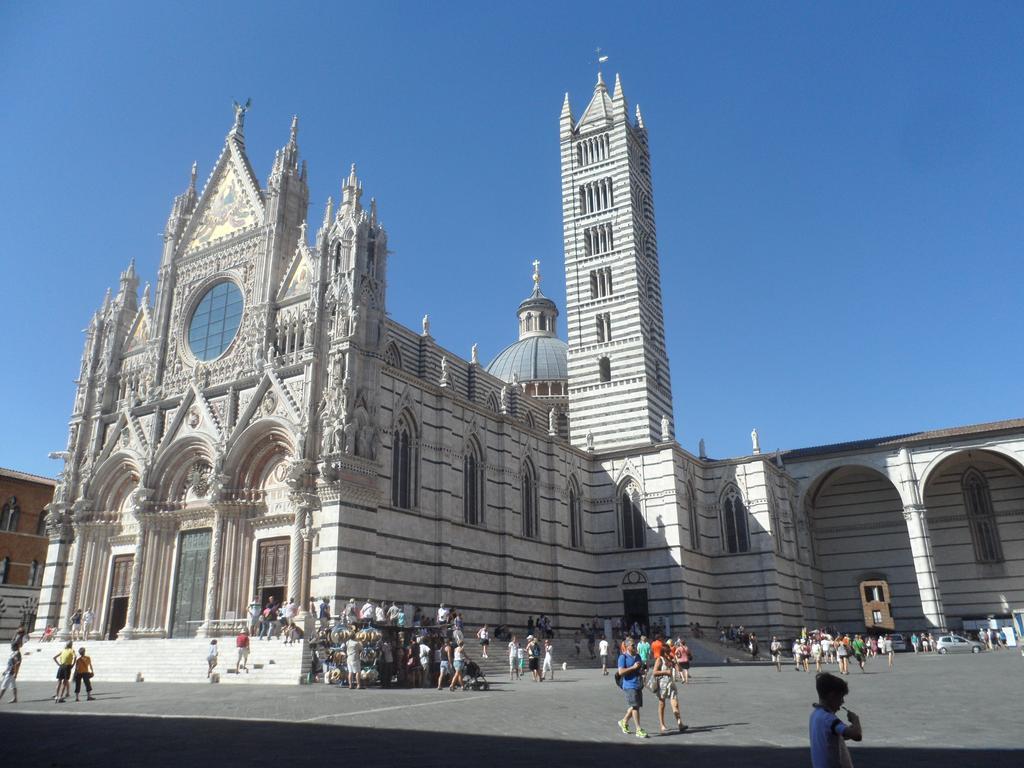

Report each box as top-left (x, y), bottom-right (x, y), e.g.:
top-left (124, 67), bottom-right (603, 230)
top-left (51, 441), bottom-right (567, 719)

top-left (0, 713), bottom-right (1024, 768)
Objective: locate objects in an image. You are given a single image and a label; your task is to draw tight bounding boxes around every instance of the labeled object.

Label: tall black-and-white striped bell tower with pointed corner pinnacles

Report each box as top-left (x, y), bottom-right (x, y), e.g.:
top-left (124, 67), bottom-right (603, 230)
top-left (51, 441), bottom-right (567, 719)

top-left (559, 73), bottom-right (674, 451)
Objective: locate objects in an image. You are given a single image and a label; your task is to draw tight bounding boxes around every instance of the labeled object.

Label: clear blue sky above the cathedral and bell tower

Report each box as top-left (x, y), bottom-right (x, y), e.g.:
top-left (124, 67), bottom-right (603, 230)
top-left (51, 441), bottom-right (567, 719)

top-left (0, 2), bottom-right (1024, 475)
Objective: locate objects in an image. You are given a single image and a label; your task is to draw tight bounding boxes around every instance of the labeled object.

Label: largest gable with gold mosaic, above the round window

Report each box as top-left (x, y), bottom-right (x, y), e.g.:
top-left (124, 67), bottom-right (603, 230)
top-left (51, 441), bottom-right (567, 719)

top-left (183, 135), bottom-right (263, 252)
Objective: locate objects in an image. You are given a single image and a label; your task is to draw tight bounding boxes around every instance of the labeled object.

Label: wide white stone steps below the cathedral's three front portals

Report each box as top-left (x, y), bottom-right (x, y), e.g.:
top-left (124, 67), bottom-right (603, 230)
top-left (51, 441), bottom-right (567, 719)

top-left (17, 637), bottom-right (309, 685)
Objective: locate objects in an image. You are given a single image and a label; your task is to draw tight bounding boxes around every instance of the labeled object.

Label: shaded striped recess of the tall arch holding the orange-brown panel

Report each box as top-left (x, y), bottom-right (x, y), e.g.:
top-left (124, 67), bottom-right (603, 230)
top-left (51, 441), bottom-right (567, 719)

top-left (805, 465), bottom-right (927, 631)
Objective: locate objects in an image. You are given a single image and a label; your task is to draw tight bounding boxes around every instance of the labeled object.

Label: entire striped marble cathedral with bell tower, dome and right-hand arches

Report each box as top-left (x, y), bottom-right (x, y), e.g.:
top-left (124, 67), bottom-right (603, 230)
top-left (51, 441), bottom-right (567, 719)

top-left (37, 77), bottom-right (1024, 639)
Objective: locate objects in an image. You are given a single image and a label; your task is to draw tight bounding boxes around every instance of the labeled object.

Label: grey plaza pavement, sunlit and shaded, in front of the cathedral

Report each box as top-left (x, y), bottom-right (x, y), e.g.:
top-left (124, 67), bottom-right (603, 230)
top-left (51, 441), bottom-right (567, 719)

top-left (0, 651), bottom-right (1024, 768)
